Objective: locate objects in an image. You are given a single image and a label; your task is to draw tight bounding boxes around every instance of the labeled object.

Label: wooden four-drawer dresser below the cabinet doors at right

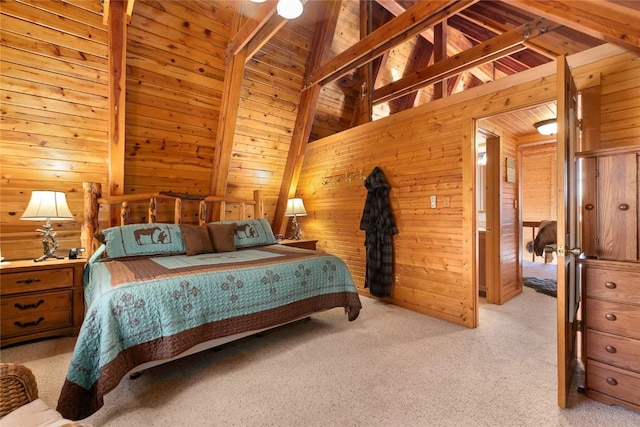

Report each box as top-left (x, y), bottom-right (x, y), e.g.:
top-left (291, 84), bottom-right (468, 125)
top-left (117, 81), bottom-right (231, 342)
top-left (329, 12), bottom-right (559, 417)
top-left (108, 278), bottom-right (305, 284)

top-left (581, 260), bottom-right (640, 411)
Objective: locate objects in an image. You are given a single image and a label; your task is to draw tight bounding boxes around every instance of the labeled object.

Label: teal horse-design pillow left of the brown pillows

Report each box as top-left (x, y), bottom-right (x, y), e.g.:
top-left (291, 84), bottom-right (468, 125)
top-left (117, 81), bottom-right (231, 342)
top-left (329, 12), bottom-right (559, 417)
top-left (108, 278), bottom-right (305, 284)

top-left (102, 223), bottom-right (186, 258)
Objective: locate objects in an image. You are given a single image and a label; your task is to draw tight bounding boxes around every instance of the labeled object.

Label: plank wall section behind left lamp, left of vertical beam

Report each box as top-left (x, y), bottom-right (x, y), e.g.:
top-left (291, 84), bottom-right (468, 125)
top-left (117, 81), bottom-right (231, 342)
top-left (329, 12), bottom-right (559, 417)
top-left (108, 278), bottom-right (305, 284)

top-left (0, 0), bottom-right (109, 259)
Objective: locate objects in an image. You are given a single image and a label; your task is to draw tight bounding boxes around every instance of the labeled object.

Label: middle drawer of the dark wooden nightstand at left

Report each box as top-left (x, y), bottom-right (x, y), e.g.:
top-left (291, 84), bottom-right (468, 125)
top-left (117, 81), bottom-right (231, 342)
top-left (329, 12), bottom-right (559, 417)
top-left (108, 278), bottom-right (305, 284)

top-left (1, 291), bottom-right (71, 322)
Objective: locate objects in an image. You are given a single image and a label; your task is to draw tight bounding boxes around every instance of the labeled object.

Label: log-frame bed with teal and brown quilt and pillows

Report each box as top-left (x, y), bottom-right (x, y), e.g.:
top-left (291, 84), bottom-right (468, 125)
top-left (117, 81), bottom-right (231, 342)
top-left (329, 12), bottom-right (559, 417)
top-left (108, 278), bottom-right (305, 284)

top-left (57, 183), bottom-right (362, 420)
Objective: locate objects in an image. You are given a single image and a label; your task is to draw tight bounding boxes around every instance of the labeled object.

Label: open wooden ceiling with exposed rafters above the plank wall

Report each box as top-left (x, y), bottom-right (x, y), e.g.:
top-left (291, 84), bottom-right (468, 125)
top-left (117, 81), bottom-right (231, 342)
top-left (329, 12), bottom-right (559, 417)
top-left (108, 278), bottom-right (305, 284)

top-left (228, 0), bottom-right (640, 141)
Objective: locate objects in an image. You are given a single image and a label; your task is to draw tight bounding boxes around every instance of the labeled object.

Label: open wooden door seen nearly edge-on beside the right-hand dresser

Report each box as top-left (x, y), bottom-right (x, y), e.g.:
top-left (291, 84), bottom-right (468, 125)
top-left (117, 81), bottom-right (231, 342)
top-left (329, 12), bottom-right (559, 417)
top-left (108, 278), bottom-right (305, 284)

top-left (557, 57), bottom-right (580, 408)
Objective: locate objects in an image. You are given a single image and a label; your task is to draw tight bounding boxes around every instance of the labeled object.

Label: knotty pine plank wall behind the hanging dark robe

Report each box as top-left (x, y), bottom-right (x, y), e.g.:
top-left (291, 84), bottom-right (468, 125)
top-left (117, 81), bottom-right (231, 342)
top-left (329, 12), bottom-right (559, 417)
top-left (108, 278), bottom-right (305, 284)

top-left (298, 47), bottom-right (640, 326)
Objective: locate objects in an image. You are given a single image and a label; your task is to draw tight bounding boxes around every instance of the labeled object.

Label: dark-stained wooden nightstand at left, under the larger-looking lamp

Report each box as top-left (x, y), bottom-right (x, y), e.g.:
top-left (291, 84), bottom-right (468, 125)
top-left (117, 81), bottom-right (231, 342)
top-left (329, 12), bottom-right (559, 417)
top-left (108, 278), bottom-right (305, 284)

top-left (0, 258), bottom-right (86, 347)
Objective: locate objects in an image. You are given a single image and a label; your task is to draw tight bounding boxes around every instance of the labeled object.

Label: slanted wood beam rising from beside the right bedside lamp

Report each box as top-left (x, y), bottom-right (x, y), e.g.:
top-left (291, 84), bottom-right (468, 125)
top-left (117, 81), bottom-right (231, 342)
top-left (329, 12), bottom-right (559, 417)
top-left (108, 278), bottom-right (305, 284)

top-left (270, 1), bottom-right (341, 233)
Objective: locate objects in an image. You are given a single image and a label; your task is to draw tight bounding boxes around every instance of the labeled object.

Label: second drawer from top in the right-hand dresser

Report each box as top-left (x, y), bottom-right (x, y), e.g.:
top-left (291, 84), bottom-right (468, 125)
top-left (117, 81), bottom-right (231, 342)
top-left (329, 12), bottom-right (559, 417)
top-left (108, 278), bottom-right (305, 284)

top-left (586, 298), bottom-right (640, 339)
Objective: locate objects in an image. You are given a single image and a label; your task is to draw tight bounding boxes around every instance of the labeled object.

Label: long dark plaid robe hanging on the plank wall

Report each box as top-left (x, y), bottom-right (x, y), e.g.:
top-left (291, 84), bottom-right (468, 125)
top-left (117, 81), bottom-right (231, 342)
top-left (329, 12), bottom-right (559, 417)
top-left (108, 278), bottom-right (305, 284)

top-left (360, 166), bottom-right (398, 298)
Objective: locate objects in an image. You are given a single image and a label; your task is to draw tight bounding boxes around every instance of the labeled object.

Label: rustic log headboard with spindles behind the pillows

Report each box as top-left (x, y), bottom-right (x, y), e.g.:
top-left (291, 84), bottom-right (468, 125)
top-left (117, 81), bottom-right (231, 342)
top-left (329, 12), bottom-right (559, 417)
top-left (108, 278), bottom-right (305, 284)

top-left (80, 182), bottom-right (264, 257)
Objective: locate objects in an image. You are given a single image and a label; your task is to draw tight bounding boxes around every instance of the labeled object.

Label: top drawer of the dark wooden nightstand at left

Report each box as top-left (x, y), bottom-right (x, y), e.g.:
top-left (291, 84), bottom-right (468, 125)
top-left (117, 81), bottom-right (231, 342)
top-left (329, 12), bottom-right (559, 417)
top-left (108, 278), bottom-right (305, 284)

top-left (0, 268), bottom-right (73, 295)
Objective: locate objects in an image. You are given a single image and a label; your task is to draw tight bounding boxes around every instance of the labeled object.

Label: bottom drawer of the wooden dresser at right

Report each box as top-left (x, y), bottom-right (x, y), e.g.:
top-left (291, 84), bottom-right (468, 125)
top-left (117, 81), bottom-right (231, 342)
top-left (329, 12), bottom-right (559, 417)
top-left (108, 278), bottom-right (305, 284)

top-left (586, 360), bottom-right (640, 405)
